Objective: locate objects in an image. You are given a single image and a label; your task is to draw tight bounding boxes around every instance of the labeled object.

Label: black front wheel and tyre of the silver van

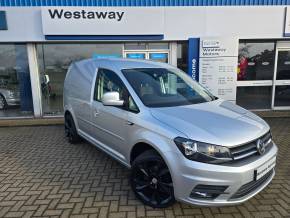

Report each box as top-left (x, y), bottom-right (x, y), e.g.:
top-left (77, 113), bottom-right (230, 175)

top-left (130, 150), bottom-right (175, 208)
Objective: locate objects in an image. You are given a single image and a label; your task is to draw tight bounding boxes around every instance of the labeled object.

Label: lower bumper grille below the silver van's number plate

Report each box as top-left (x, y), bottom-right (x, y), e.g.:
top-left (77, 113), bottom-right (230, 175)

top-left (231, 169), bottom-right (274, 200)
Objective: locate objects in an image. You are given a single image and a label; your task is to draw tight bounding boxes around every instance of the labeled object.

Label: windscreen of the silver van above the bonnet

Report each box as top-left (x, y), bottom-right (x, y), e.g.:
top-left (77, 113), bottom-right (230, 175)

top-left (122, 68), bottom-right (216, 107)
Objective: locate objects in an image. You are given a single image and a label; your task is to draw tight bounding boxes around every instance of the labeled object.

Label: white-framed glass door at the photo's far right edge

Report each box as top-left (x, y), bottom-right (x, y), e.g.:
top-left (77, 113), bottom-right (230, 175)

top-left (272, 48), bottom-right (290, 109)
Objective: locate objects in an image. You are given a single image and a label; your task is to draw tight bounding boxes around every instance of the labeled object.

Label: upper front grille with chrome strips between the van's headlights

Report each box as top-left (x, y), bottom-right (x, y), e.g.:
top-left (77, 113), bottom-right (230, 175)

top-left (230, 132), bottom-right (273, 160)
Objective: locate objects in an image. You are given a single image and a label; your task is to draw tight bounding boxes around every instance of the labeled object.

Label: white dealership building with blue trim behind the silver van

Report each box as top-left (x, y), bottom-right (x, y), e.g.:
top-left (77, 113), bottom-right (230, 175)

top-left (0, 0), bottom-right (290, 119)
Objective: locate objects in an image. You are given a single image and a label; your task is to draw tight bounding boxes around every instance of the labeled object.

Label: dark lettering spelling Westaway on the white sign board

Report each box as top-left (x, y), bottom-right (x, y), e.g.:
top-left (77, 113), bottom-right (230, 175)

top-left (48, 9), bottom-right (125, 21)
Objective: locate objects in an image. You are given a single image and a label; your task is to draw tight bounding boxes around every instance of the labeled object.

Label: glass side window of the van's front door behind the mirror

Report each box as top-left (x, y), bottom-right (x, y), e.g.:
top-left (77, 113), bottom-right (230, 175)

top-left (94, 69), bottom-right (139, 112)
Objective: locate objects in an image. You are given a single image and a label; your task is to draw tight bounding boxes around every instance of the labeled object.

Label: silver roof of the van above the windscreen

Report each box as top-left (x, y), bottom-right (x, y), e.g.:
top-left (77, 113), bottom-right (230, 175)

top-left (75, 58), bottom-right (173, 70)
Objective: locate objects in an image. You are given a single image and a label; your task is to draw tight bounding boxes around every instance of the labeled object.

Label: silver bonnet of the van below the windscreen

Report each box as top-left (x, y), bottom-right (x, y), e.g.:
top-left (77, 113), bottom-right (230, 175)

top-left (150, 100), bottom-right (270, 147)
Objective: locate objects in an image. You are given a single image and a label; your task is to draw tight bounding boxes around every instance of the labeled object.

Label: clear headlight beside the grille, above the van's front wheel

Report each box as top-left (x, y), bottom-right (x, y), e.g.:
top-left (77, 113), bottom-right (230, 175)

top-left (174, 137), bottom-right (233, 163)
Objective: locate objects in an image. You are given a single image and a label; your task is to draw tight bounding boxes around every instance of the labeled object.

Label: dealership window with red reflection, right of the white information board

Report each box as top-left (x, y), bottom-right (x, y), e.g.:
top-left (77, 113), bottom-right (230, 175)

top-left (237, 40), bottom-right (275, 109)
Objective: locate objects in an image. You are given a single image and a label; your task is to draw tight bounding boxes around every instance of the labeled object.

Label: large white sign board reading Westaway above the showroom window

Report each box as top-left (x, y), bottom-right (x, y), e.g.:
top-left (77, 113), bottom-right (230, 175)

top-left (41, 6), bottom-right (164, 37)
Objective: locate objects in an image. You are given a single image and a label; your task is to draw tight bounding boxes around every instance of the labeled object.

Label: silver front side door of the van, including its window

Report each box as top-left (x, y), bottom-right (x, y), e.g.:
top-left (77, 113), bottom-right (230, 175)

top-left (91, 69), bottom-right (128, 161)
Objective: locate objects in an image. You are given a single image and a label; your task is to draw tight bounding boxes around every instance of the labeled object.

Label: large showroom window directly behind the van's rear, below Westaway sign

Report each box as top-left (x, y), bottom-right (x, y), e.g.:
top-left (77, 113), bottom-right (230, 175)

top-left (37, 43), bottom-right (123, 115)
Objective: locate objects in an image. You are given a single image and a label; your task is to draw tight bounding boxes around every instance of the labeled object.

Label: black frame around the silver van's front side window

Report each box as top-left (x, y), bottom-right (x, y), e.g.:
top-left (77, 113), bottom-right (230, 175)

top-left (92, 67), bottom-right (140, 114)
